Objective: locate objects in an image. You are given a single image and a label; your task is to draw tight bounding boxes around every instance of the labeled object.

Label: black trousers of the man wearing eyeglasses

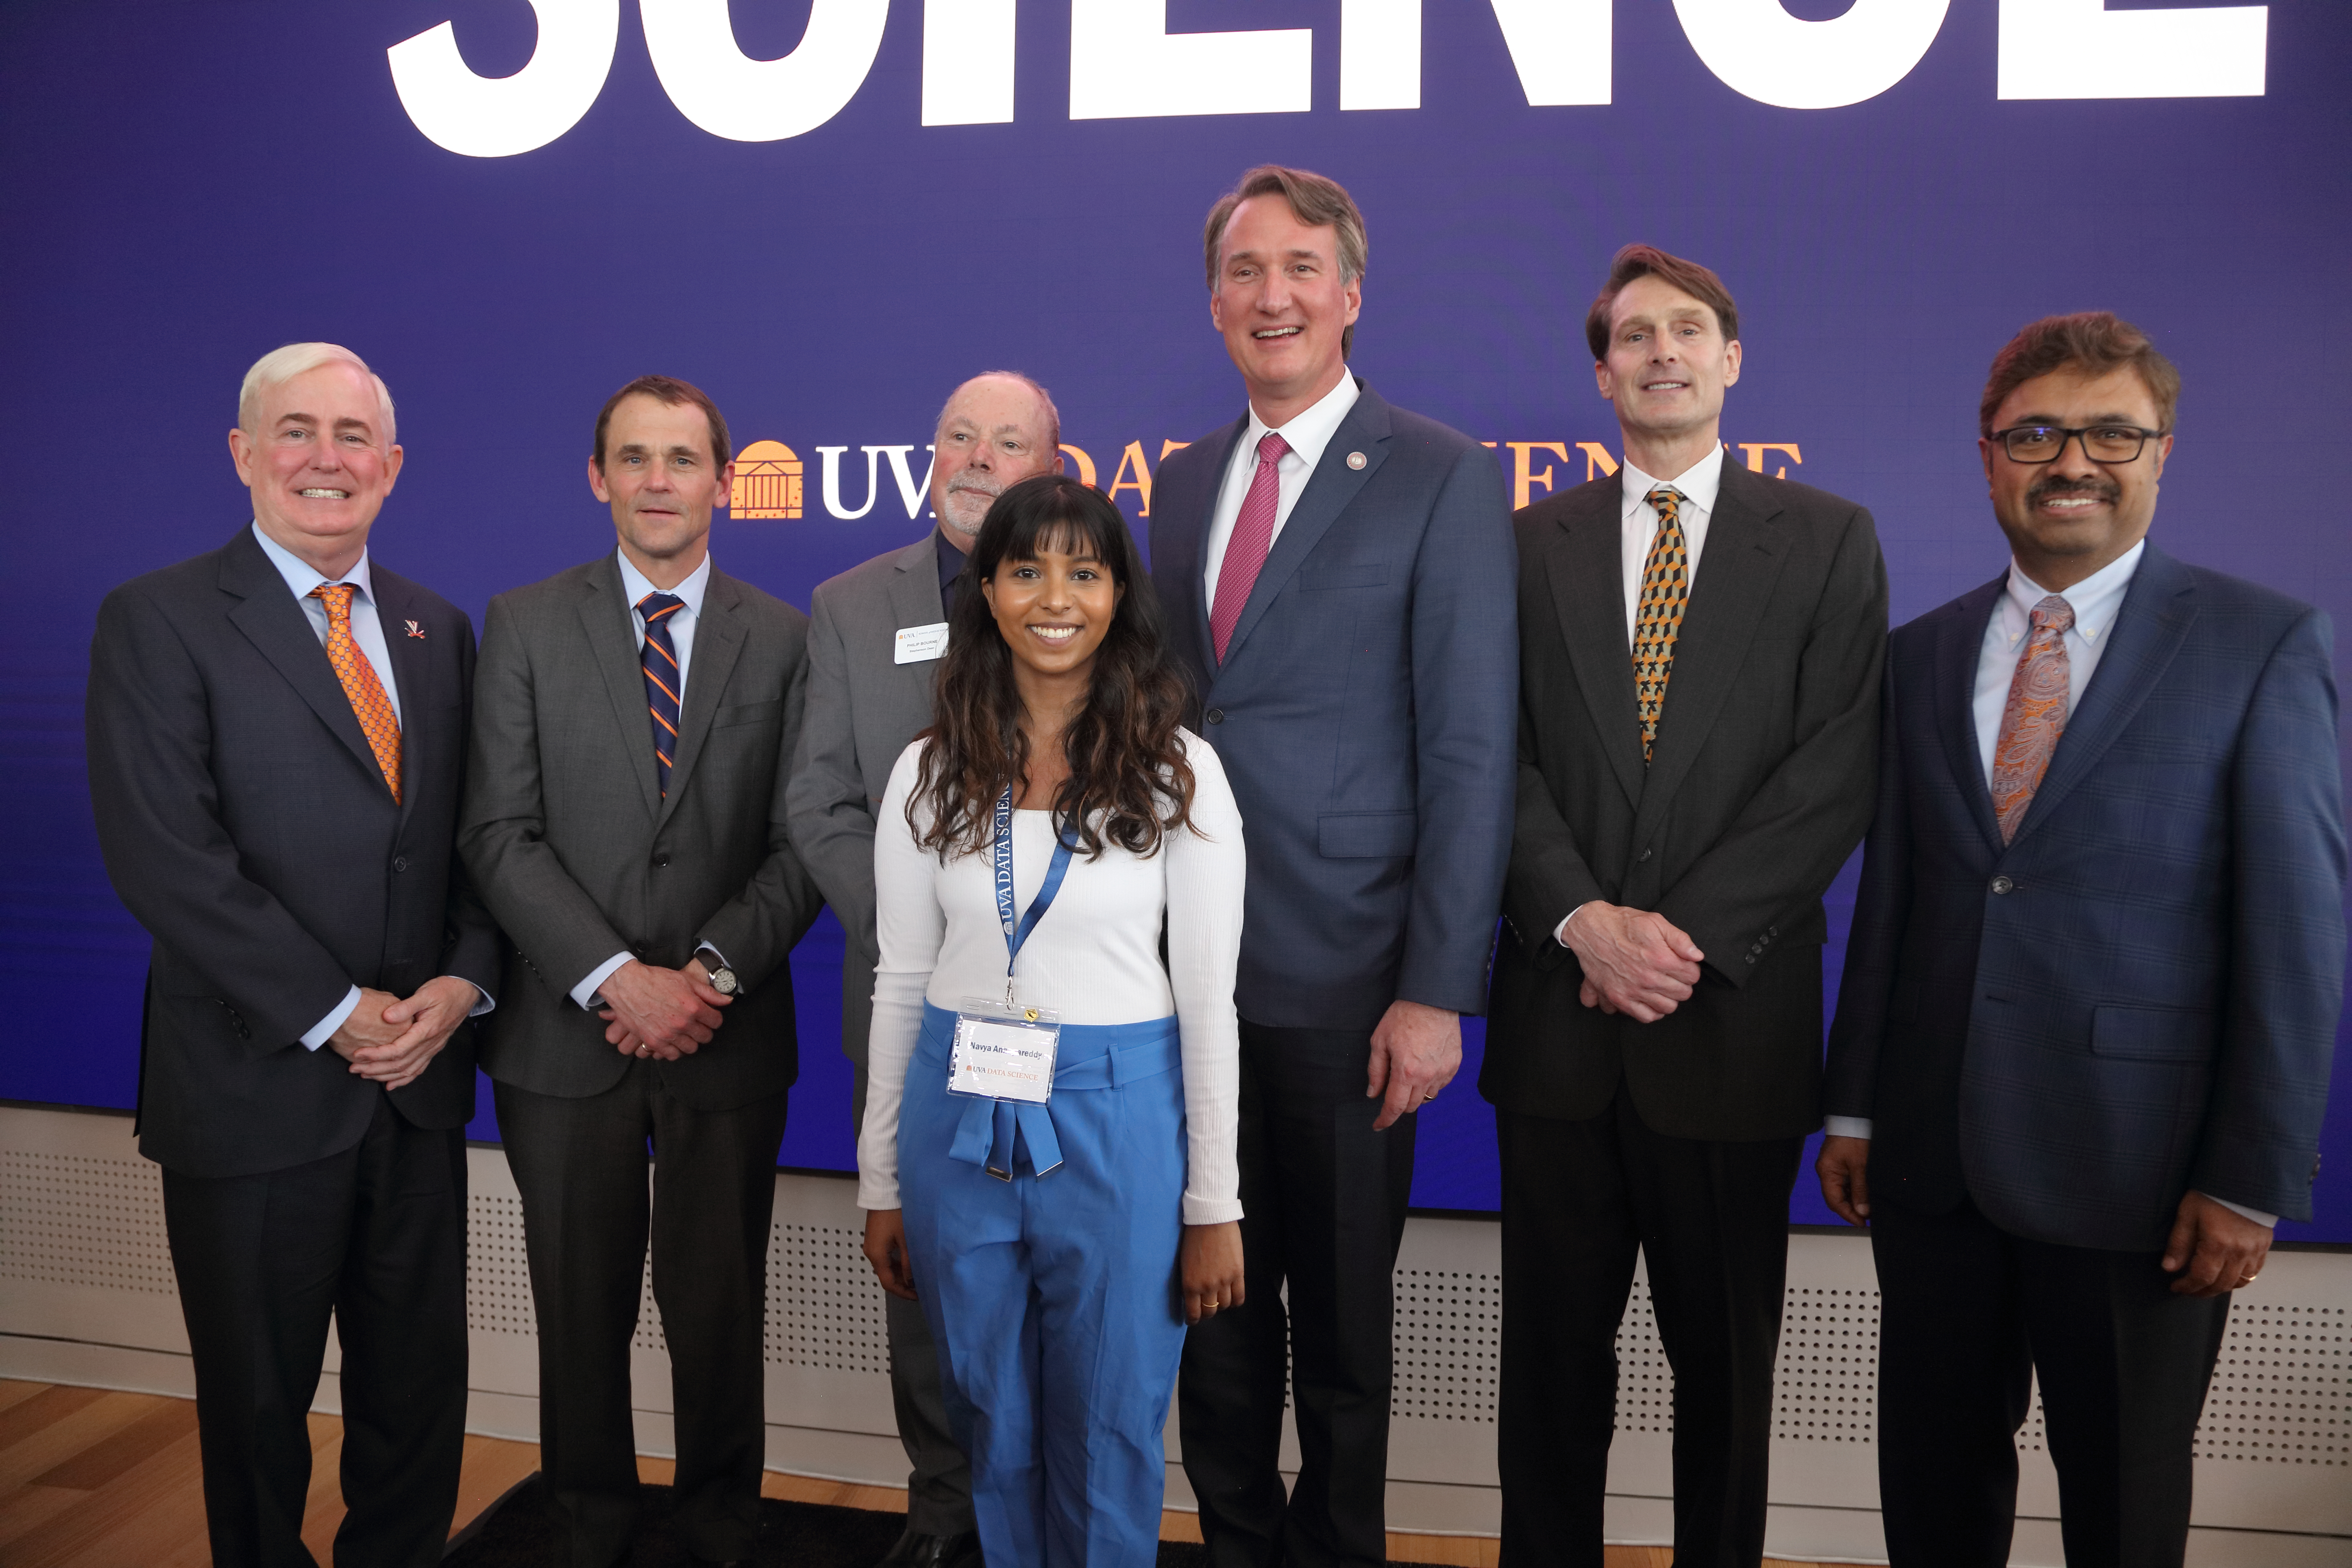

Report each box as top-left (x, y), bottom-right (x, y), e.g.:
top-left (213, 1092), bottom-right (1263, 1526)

top-left (1870, 1197), bottom-right (2230, 1568)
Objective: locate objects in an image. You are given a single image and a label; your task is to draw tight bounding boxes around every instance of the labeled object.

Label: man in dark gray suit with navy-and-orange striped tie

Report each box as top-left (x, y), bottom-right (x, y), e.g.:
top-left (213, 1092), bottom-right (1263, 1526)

top-left (461, 376), bottom-right (818, 1568)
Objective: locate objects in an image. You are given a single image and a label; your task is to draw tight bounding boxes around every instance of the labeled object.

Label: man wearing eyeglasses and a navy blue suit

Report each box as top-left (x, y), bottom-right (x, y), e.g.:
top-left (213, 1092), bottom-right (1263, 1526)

top-left (1818, 313), bottom-right (2345, 1566)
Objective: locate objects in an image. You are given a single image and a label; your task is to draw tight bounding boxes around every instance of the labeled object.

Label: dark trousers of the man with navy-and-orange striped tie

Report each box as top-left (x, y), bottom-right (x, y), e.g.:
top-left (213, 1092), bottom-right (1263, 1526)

top-left (496, 1062), bottom-right (785, 1568)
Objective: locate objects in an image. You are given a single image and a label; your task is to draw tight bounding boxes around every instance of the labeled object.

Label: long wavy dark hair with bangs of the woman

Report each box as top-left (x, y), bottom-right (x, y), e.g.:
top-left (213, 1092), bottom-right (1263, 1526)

top-left (906, 475), bottom-right (1192, 860)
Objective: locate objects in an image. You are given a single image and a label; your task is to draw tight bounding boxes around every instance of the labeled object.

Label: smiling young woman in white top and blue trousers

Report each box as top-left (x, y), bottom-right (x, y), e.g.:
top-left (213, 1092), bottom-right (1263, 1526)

top-left (858, 475), bottom-right (1244, 1568)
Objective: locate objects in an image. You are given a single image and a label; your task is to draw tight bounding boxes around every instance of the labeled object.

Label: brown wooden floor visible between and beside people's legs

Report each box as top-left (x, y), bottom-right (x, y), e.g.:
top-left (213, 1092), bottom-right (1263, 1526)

top-left (0, 1380), bottom-right (1811, 1568)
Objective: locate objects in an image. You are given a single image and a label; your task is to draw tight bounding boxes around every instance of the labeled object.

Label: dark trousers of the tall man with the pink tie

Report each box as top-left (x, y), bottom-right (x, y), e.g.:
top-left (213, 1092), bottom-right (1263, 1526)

top-left (1176, 1018), bottom-right (1416, 1568)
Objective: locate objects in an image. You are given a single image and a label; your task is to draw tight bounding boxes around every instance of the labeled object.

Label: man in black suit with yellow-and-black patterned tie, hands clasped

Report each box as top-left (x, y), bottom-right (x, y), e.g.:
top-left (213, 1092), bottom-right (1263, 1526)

top-left (1479, 245), bottom-right (1886, 1568)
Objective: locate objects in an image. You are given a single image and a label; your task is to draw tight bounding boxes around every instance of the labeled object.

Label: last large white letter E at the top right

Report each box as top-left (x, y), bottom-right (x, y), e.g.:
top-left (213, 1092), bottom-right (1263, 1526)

top-left (1999, 0), bottom-right (2270, 99)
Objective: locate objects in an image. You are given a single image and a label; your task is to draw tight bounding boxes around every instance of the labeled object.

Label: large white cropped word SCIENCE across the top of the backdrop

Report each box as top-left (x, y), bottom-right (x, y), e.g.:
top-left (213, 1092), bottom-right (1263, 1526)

top-left (388, 0), bottom-right (2270, 158)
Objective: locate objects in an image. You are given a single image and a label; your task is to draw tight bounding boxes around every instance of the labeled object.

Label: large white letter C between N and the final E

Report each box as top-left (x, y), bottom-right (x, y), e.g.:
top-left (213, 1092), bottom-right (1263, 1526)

top-left (1675, 0), bottom-right (1950, 108)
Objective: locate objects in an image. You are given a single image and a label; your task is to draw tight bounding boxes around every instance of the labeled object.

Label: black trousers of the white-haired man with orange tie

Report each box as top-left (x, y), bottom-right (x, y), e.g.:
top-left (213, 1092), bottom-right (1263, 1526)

top-left (162, 1095), bottom-right (466, 1568)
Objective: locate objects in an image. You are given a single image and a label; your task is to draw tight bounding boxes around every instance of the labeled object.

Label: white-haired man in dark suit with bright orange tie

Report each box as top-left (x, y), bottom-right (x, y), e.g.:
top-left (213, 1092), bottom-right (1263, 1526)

top-left (87, 343), bottom-right (499, 1568)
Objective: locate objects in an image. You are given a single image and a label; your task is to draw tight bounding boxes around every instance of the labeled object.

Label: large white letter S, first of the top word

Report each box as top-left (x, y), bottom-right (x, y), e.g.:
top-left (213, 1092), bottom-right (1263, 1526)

top-left (388, 0), bottom-right (621, 158)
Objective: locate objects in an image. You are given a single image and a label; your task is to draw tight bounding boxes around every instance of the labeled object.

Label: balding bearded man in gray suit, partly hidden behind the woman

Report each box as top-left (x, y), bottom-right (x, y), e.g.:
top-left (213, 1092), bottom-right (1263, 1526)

top-left (785, 371), bottom-right (1061, 1568)
